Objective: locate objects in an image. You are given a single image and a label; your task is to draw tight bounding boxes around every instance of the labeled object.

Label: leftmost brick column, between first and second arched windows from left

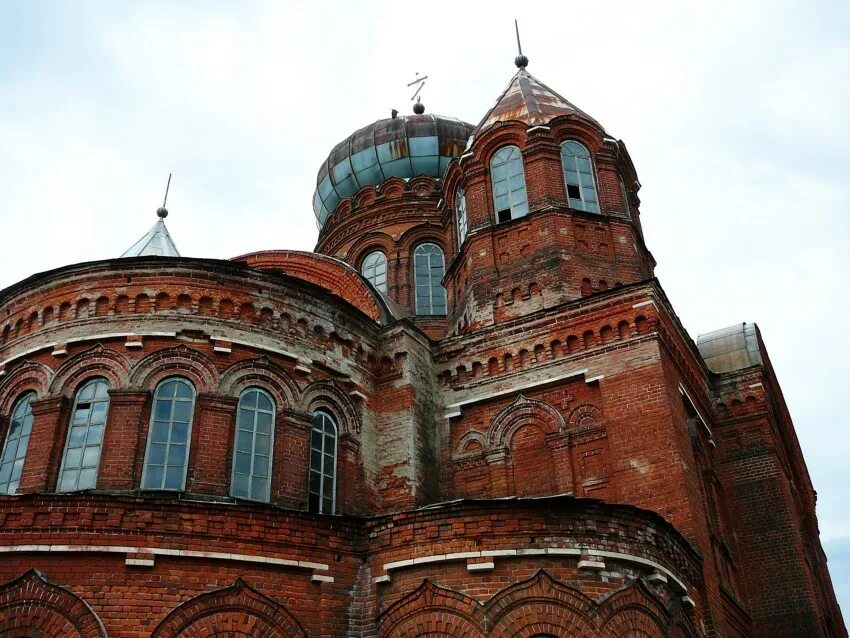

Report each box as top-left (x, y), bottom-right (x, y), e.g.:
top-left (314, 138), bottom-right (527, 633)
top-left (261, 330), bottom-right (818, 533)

top-left (18, 397), bottom-right (68, 494)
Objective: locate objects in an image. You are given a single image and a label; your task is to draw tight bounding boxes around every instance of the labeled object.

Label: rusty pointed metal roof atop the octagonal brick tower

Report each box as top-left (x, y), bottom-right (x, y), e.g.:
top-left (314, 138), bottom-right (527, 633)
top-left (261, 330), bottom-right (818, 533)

top-left (475, 69), bottom-right (599, 134)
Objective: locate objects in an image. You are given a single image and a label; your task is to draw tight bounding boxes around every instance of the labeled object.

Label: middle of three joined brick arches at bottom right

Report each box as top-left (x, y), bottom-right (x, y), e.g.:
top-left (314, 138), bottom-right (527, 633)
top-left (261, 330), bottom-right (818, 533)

top-left (486, 570), bottom-right (598, 638)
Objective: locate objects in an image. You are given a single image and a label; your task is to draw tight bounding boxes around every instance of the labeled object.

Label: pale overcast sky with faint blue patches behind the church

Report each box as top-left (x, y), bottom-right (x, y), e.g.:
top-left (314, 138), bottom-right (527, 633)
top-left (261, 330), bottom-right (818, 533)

top-left (0, 0), bottom-right (850, 620)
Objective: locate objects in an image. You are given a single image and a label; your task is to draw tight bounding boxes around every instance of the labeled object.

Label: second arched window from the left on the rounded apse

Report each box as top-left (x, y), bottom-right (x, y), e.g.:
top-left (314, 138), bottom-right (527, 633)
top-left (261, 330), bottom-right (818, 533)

top-left (56, 378), bottom-right (109, 492)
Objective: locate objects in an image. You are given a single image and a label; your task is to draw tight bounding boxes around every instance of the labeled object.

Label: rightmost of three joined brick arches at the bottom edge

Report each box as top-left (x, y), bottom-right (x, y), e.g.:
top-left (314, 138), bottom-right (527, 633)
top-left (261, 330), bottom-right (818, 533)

top-left (599, 580), bottom-right (669, 638)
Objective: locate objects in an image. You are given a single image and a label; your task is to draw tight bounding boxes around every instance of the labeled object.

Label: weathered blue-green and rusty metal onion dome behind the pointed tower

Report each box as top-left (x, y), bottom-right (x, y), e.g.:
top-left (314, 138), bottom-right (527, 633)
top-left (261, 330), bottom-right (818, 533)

top-left (313, 114), bottom-right (474, 228)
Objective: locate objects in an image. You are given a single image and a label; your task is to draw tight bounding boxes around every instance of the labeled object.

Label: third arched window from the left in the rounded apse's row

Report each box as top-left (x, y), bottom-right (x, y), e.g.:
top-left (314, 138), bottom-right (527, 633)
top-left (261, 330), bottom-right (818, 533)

top-left (142, 377), bottom-right (195, 490)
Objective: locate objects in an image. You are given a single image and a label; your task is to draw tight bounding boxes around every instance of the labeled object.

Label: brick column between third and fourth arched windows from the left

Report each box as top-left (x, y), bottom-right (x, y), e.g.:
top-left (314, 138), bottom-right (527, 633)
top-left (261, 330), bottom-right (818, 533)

top-left (186, 393), bottom-right (239, 496)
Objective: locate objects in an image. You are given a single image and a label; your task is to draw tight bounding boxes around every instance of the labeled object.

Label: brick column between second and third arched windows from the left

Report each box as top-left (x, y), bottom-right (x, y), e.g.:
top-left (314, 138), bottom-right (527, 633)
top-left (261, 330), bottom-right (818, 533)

top-left (97, 390), bottom-right (151, 490)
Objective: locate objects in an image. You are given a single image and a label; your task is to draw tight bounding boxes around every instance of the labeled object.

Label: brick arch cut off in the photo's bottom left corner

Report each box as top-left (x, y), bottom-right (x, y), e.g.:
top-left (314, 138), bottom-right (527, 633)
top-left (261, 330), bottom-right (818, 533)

top-left (0, 569), bottom-right (106, 638)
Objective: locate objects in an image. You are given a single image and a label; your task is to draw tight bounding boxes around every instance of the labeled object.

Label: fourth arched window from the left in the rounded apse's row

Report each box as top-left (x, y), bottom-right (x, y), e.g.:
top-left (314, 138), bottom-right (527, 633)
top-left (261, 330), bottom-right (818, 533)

top-left (230, 388), bottom-right (275, 501)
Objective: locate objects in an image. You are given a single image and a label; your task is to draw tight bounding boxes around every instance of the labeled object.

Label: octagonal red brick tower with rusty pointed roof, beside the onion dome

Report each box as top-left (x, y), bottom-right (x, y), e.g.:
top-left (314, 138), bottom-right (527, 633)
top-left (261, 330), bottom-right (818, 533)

top-left (443, 55), bottom-right (655, 334)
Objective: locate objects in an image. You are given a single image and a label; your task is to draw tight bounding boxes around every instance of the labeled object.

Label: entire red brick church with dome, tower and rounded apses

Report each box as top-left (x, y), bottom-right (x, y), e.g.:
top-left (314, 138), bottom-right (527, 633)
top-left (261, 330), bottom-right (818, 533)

top-left (0, 51), bottom-right (847, 638)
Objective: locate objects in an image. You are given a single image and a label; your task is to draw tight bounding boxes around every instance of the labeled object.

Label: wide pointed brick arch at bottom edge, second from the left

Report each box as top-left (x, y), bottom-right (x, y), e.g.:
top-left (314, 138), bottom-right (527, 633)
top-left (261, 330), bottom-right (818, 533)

top-left (151, 578), bottom-right (307, 638)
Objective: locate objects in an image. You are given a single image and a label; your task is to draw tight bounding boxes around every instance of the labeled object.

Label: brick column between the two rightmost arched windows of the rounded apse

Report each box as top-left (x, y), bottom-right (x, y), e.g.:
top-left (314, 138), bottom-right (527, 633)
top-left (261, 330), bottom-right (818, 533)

top-left (271, 408), bottom-right (313, 510)
